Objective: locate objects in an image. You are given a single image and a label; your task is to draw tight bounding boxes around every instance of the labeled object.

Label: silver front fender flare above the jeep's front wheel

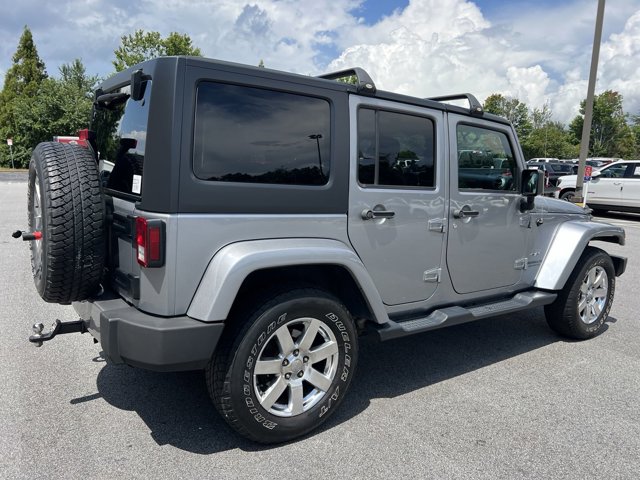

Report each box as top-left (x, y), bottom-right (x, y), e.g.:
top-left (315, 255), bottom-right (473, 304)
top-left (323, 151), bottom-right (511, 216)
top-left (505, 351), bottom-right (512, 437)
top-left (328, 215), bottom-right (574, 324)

top-left (535, 221), bottom-right (625, 290)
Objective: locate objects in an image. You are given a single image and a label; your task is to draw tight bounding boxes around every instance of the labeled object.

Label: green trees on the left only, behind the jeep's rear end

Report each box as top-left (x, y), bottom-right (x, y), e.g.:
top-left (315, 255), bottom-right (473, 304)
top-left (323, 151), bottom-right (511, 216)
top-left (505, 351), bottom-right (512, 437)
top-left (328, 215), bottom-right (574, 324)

top-left (0, 27), bottom-right (202, 168)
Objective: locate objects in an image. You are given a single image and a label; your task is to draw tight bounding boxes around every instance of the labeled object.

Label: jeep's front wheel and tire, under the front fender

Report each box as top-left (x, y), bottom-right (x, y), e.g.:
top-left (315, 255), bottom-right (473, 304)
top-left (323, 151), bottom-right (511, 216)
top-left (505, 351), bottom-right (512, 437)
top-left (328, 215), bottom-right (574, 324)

top-left (545, 247), bottom-right (616, 340)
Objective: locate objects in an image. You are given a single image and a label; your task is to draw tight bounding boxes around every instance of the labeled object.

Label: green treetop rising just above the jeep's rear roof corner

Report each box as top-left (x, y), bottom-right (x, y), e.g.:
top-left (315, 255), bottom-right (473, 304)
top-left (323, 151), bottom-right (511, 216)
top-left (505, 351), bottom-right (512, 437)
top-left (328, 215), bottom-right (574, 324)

top-left (113, 30), bottom-right (202, 72)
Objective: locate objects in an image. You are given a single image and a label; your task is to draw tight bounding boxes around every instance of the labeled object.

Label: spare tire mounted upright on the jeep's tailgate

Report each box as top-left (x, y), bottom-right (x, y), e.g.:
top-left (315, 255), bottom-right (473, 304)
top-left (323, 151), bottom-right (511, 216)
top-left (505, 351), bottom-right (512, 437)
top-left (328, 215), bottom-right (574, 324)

top-left (28, 142), bottom-right (105, 303)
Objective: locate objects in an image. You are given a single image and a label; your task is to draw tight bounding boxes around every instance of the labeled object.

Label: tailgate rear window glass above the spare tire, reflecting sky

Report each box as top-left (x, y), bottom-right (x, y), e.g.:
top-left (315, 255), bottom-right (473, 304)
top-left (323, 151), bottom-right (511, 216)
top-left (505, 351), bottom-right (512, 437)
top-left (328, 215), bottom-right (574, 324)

top-left (91, 81), bottom-right (151, 196)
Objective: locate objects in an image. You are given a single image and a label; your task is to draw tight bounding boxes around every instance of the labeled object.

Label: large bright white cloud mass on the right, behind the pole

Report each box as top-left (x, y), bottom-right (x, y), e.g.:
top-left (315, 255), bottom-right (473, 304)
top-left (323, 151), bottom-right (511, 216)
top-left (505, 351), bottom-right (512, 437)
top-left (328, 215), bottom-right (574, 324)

top-left (330, 0), bottom-right (640, 123)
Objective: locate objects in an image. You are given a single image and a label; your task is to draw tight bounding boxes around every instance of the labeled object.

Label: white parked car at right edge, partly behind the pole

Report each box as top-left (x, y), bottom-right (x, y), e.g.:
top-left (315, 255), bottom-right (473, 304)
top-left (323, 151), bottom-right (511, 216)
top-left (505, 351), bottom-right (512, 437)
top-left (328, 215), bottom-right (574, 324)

top-left (556, 160), bottom-right (640, 212)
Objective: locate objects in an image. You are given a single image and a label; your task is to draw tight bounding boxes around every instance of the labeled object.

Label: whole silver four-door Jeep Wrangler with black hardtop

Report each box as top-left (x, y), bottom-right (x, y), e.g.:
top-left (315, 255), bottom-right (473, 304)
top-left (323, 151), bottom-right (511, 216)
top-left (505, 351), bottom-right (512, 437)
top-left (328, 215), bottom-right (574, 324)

top-left (19, 57), bottom-right (626, 443)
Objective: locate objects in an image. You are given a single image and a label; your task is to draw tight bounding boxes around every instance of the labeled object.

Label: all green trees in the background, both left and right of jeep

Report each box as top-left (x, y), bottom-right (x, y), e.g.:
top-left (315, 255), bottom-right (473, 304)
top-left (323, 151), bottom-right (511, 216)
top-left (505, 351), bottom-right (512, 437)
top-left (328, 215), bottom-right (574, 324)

top-left (0, 26), bottom-right (640, 168)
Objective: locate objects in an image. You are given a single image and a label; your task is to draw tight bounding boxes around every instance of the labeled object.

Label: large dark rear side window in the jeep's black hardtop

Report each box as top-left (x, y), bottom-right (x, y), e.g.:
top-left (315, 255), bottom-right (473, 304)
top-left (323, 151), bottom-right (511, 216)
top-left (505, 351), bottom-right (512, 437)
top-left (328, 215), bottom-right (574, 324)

top-left (193, 82), bottom-right (331, 185)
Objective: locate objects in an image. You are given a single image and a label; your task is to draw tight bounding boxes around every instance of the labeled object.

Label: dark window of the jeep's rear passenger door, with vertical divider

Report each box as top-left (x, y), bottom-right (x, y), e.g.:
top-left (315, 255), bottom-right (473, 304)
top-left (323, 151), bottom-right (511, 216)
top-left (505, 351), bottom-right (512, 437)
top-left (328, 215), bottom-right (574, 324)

top-left (358, 108), bottom-right (435, 187)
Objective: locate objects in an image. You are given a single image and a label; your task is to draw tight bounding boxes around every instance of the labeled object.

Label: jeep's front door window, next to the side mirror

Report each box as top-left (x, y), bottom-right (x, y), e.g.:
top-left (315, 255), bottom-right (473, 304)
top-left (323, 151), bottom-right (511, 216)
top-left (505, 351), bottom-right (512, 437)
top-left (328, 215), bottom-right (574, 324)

top-left (457, 125), bottom-right (516, 191)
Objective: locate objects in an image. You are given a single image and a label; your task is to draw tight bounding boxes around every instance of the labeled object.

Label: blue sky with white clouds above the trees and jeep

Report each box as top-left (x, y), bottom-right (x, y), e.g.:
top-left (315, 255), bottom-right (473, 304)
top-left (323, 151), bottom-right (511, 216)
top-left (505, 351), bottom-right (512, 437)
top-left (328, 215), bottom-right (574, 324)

top-left (0, 0), bottom-right (640, 123)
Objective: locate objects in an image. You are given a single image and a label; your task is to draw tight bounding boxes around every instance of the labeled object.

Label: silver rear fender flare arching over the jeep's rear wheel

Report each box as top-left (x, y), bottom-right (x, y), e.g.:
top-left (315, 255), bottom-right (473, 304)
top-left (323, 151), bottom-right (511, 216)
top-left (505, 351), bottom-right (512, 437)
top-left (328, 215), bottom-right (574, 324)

top-left (187, 238), bottom-right (388, 323)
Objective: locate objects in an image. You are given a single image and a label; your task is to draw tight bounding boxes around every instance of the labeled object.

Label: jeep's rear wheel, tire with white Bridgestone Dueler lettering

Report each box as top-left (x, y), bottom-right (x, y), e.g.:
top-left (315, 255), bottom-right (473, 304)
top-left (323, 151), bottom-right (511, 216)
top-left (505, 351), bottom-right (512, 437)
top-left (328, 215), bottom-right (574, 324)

top-left (206, 288), bottom-right (358, 443)
